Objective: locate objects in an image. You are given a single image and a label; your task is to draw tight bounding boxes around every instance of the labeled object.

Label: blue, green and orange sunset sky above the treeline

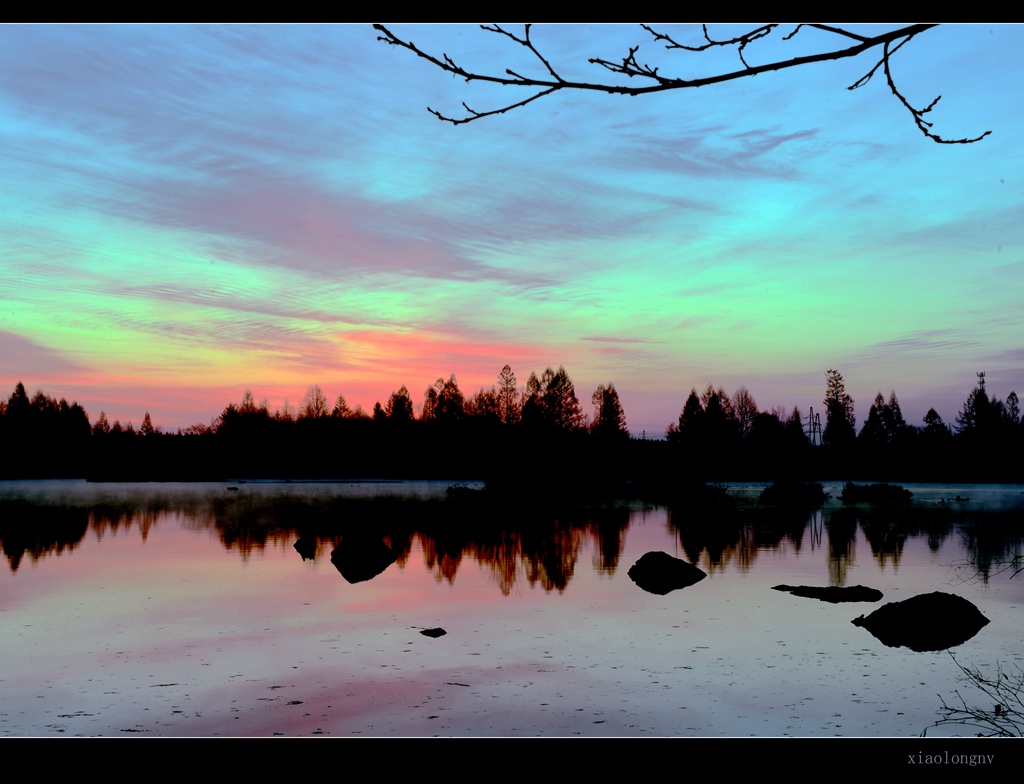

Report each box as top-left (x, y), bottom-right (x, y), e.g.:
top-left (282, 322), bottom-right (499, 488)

top-left (0, 25), bottom-right (1024, 437)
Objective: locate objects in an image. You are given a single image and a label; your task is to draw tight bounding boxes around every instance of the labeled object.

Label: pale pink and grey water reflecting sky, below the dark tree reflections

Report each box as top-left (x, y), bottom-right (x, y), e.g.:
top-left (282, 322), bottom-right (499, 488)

top-left (0, 485), bottom-right (1024, 736)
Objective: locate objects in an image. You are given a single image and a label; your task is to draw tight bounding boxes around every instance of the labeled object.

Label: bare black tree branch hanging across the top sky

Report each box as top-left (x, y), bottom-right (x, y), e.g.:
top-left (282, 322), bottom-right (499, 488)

top-left (374, 24), bottom-right (991, 144)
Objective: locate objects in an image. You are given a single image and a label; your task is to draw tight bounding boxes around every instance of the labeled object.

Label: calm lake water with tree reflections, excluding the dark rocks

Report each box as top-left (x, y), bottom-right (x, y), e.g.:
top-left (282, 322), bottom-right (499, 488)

top-left (0, 481), bottom-right (1024, 737)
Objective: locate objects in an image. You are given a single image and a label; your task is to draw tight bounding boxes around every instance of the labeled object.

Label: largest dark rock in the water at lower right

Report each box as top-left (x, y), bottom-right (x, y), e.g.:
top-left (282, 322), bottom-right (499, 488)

top-left (852, 592), bottom-right (988, 651)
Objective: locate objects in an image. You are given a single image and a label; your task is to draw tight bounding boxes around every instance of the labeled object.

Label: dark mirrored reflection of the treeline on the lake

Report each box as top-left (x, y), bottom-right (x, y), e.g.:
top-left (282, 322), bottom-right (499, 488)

top-left (0, 485), bottom-right (1024, 596)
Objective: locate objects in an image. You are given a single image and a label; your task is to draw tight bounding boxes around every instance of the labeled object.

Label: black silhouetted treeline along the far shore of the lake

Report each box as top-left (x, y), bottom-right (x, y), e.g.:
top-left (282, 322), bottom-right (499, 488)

top-left (0, 365), bottom-right (1024, 485)
